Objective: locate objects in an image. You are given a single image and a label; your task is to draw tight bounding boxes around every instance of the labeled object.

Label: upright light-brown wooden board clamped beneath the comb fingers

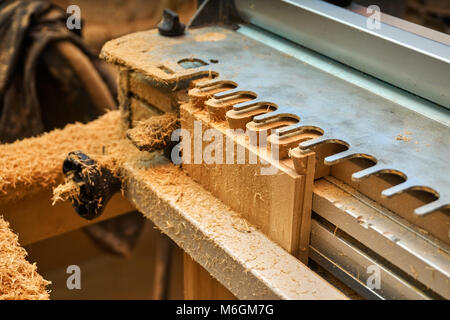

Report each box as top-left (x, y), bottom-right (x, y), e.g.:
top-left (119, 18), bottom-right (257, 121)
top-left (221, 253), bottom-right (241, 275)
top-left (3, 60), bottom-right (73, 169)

top-left (180, 104), bottom-right (312, 263)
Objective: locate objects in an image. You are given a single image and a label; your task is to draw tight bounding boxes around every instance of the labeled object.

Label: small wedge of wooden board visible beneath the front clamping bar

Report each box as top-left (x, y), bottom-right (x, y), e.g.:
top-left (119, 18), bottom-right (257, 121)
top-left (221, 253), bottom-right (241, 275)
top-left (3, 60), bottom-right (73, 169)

top-left (184, 253), bottom-right (236, 300)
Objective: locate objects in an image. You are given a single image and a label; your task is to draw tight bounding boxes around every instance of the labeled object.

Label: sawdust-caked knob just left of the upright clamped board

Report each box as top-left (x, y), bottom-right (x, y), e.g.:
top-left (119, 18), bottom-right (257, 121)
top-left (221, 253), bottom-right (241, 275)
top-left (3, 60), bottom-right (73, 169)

top-left (127, 113), bottom-right (180, 152)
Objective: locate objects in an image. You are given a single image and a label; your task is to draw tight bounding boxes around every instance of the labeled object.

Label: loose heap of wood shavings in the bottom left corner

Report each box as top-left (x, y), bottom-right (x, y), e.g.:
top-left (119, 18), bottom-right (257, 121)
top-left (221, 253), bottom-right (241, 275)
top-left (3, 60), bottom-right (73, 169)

top-left (0, 216), bottom-right (50, 300)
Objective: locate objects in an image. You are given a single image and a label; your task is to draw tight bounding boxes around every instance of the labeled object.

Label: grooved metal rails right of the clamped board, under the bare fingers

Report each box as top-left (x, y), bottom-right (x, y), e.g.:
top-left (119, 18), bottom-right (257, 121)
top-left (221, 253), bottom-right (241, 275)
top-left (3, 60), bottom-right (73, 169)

top-left (311, 177), bottom-right (450, 299)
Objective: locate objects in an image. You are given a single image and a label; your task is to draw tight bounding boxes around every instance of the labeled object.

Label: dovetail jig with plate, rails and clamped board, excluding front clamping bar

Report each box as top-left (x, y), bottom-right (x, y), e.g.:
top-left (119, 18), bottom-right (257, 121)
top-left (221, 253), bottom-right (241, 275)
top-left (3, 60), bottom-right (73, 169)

top-left (96, 0), bottom-right (450, 299)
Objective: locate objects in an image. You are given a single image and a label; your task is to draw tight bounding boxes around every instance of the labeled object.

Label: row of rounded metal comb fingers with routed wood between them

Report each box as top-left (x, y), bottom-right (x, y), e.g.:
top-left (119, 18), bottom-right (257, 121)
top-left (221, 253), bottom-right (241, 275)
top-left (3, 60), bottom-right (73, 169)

top-left (185, 77), bottom-right (449, 215)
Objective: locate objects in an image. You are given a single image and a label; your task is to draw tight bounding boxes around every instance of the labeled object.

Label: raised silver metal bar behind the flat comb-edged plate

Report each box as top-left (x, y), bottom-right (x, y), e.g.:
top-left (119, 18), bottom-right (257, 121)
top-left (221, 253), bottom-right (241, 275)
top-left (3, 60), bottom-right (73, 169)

top-left (235, 0), bottom-right (450, 108)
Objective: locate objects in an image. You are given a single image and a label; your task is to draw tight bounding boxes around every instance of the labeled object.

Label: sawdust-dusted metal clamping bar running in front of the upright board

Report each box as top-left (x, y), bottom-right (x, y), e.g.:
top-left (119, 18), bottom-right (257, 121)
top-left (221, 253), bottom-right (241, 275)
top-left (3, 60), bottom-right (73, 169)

top-left (123, 156), bottom-right (346, 299)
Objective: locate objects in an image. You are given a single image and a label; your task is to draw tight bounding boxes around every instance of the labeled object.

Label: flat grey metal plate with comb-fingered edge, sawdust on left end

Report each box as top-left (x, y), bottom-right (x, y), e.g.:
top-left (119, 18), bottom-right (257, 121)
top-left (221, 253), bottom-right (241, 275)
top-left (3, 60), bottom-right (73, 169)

top-left (102, 27), bottom-right (450, 215)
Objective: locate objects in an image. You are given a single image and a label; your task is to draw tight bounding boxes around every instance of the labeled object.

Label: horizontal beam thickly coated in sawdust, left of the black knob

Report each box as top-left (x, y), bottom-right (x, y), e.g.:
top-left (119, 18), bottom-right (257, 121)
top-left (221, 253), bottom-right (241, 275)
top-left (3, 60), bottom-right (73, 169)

top-left (0, 111), bottom-right (152, 203)
